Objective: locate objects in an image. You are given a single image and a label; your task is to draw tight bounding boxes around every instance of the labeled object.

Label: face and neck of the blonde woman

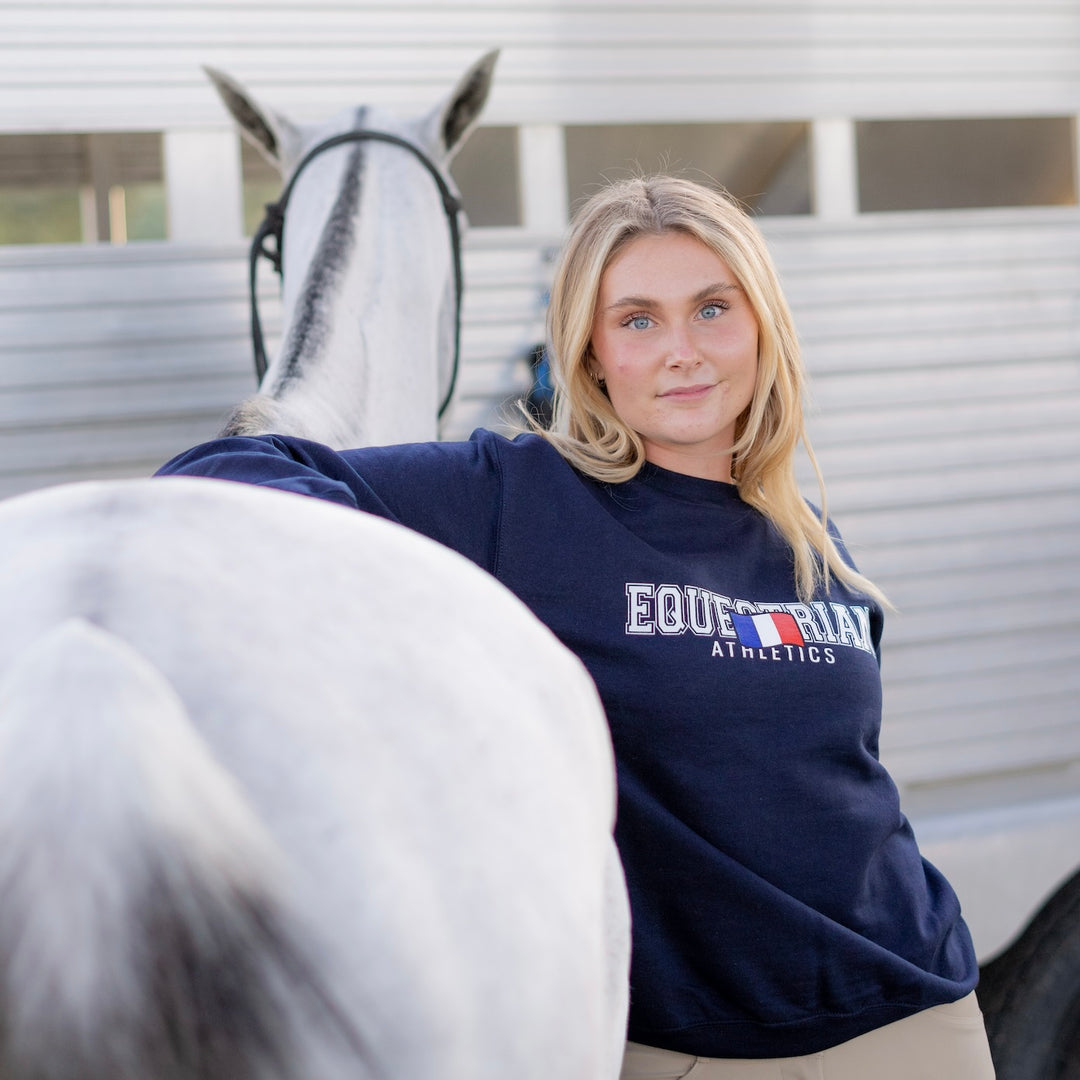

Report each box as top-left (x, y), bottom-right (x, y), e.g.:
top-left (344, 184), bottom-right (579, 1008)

top-left (591, 232), bottom-right (758, 481)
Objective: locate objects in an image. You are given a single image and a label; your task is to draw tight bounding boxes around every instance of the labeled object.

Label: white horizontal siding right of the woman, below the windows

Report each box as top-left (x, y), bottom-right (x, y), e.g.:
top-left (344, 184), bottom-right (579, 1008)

top-left (766, 211), bottom-right (1080, 786)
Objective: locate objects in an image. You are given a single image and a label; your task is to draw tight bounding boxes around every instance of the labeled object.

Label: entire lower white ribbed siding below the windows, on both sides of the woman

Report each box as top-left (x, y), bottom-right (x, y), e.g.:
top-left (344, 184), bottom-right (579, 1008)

top-left (0, 210), bottom-right (1080, 788)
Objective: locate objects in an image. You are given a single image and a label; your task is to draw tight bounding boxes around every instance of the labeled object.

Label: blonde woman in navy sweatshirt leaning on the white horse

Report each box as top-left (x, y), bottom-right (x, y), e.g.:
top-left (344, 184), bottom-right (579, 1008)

top-left (157, 177), bottom-right (993, 1080)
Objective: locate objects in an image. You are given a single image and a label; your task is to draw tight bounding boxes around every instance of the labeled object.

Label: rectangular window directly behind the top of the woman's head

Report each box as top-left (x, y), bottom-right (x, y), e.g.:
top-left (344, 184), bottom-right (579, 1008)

top-left (566, 123), bottom-right (810, 214)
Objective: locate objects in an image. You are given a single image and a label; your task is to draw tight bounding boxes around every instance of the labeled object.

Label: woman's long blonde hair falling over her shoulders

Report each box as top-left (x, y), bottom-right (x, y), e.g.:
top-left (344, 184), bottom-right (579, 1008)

top-left (542, 176), bottom-right (888, 604)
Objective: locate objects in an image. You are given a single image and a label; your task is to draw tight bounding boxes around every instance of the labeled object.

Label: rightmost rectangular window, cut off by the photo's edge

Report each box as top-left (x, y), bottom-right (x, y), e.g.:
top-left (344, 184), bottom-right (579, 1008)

top-left (855, 117), bottom-right (1077, 212)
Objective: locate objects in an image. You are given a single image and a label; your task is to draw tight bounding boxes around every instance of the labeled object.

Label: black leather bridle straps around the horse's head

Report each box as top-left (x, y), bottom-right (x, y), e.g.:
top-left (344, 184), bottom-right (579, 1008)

top-left (248, 127), bottom-right (463, 418)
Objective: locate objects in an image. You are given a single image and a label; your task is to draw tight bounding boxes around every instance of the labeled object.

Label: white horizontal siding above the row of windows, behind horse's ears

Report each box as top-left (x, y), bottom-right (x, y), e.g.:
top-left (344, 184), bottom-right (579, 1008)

top-left (0, 0), bottom-right (1080, 132)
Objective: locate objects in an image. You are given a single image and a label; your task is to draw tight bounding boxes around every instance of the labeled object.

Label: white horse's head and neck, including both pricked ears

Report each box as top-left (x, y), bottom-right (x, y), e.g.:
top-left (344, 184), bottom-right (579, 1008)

top-left (206, 51), bottom-right (498, 447)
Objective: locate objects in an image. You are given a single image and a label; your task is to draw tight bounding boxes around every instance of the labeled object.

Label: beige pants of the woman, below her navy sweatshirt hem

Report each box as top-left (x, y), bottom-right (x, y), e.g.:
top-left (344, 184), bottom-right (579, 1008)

top-left (621, 994), bottom-right (994, 1080)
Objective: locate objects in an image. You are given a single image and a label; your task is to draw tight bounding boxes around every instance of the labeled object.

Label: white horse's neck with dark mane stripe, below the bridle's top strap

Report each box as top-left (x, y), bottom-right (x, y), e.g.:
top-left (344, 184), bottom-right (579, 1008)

top-left (264, 131), bottom-right (453, 447)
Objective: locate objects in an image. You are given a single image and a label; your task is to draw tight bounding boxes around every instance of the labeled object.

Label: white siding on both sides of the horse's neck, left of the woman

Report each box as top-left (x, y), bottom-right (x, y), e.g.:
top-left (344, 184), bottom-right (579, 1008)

top-left (0, 230), bottom-right (550, 497)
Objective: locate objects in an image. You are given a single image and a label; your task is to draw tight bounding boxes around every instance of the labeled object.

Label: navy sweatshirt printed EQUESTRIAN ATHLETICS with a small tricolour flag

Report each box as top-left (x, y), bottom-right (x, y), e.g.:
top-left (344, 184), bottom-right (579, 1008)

top-left (162, 431), bottom-right (977, 1057)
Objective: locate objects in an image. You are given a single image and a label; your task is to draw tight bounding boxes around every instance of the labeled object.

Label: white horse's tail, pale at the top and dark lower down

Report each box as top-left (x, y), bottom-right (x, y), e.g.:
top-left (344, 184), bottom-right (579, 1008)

top-left (0, 619), bottom-right (367, 1080)
